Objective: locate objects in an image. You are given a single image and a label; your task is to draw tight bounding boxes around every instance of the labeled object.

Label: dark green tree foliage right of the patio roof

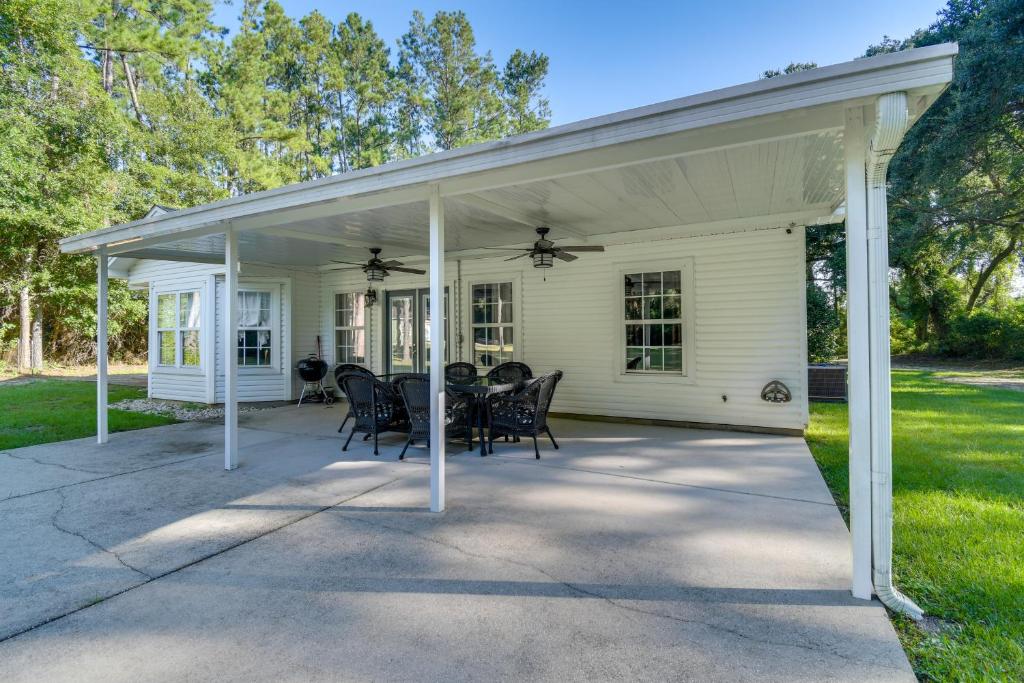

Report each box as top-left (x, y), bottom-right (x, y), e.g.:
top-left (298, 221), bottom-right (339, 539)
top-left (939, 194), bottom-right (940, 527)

top-left (798, 0), bottom-right (1024, 358)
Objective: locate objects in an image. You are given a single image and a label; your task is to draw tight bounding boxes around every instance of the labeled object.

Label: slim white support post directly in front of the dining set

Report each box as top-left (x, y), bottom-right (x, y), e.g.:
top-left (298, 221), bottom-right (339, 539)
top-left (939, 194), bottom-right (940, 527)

top-left (430, 185), bottom-right (444, 512)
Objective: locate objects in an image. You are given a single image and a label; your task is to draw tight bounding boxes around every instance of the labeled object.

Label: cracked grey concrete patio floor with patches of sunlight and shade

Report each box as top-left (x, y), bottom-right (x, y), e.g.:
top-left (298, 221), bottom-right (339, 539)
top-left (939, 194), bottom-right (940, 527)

top-left (0, 405), bottom-right (913, 681)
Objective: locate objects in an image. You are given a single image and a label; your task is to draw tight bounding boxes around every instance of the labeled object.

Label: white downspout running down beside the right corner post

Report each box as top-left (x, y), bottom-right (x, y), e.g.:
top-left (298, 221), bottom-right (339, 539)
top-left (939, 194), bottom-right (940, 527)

top-left (867, 92), bottom-right (924, 620)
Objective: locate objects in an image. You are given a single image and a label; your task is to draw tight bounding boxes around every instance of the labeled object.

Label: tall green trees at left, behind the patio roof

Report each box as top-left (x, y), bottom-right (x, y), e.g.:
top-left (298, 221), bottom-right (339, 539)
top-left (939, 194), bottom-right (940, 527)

top-left (0, 0), bottom-right (550, 365)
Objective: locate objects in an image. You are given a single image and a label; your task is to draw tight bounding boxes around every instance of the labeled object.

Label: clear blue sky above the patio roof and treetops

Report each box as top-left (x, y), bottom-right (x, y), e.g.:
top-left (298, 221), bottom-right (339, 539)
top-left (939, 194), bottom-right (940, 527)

top-left (215, 0), bottom-right (944, 125)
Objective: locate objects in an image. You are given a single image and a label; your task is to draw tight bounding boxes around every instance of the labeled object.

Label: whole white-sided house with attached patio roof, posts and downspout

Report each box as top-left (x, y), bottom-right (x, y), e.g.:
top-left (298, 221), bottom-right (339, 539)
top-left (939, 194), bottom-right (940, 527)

top-left (68, 44), bottom-right (956, 617)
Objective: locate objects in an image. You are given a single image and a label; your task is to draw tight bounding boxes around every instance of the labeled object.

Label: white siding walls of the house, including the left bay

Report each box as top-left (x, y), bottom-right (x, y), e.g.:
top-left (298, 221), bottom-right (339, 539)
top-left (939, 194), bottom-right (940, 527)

top-left (121, 219), bottom-right (807, 431)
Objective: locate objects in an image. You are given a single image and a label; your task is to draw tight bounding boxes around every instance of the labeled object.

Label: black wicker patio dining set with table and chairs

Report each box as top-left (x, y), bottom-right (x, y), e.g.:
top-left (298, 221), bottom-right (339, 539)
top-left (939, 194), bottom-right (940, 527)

top-left (334, 361), bottom-right (562, 460)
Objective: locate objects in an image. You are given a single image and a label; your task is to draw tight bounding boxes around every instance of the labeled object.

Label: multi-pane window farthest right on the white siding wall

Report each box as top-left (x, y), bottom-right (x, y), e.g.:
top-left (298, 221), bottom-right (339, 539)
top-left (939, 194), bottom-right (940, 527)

top-left (623, 270), bottom-right (683, 374)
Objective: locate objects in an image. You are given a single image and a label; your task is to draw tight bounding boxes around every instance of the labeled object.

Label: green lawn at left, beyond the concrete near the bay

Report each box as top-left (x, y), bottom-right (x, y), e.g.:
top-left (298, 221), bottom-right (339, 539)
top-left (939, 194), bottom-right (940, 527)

top-left (0, 380), bottom-right (174, 450)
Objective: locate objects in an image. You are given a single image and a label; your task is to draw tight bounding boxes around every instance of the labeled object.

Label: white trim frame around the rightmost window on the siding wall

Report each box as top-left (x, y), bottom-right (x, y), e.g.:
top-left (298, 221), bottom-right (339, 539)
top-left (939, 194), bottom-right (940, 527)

top-left (612, 256), bottom-right (696, 384)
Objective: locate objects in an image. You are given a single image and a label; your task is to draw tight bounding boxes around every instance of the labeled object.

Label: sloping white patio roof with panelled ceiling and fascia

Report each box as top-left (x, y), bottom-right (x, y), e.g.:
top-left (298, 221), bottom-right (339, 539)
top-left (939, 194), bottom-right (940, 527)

top-left (60, 44), bottom-right (956, 267)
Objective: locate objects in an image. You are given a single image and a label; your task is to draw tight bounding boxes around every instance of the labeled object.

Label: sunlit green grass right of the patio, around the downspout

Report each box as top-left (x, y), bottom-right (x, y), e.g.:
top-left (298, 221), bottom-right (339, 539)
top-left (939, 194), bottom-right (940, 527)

top-left (807, 371), bottom-right (1024, 681)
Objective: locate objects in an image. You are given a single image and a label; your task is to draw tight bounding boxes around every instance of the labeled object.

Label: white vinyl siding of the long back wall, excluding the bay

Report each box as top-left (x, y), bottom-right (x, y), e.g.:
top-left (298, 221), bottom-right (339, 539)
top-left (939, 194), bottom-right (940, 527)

top-left (322, 227), bottom-right (807, 429)
